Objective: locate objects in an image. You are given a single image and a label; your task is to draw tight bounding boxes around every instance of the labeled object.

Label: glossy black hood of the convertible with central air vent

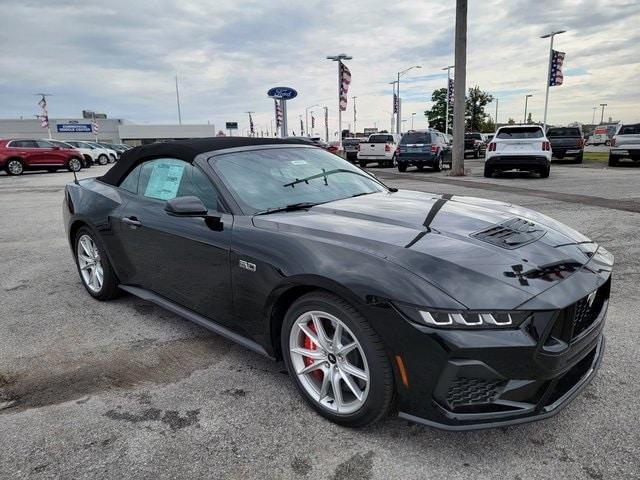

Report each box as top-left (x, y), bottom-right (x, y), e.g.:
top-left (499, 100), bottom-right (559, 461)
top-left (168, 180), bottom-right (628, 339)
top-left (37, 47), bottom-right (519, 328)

top-left (253, 190), bottom-right (598, 308)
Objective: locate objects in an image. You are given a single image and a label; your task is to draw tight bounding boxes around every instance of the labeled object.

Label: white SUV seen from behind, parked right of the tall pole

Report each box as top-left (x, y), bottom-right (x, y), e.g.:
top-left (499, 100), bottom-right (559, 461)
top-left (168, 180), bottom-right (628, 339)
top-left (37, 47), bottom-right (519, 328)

top-left (484, 125), bottom-right (551, 178)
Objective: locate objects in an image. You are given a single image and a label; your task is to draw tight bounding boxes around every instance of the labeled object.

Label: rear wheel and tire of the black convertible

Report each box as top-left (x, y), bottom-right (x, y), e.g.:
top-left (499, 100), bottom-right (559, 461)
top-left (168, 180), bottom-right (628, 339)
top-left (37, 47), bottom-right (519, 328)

top-left (73, 227), bottom-right (120, 300)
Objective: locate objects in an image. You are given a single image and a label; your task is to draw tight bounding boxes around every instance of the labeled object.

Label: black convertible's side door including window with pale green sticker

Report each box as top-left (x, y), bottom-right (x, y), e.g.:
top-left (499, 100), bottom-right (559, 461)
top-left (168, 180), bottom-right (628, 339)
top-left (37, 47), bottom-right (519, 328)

top-left (116, 158), bottom-right (233, 324)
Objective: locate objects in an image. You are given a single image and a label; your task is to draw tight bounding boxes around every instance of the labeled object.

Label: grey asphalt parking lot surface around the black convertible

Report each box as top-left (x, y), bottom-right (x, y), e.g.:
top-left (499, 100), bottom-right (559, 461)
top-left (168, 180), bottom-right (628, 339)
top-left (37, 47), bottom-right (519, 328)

top-left (0, 160), bottom-right (640, 480)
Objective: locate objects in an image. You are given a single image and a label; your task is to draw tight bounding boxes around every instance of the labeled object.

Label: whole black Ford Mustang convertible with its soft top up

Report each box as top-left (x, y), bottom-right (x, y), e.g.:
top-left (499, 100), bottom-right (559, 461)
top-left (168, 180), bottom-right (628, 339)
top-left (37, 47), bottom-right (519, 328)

top-left (63, 138), bottom-right (613, 430)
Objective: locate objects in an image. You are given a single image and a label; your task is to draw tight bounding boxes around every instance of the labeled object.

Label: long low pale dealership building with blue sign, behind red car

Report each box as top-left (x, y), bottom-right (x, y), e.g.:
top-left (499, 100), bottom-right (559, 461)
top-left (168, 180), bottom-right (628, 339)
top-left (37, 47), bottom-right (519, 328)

top-left (0, 118), bottom-right (216, 146)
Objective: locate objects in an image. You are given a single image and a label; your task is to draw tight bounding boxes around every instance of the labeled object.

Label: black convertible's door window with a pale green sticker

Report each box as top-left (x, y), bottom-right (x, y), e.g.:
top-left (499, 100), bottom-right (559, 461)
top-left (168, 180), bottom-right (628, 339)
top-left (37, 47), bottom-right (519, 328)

top-left (136, 158), bottom-right (218, 210)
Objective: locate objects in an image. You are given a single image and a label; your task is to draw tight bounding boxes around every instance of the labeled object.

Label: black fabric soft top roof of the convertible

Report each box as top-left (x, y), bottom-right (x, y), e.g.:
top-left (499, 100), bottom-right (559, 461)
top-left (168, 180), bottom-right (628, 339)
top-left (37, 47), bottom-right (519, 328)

top-left (100, 137), bottom-right (309, 185)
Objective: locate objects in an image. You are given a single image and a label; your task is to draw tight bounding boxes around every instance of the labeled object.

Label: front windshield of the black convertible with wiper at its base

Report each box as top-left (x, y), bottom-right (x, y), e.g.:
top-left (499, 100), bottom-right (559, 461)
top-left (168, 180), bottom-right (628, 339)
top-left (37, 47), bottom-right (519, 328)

top-left (212, 148), bottom-right (386, 213)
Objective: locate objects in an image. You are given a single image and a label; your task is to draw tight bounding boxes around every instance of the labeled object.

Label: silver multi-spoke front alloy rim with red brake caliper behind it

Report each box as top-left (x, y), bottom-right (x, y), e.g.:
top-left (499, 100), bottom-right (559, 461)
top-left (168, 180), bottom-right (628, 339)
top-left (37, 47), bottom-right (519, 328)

top-left (289, 311), bottom-right (370, 415)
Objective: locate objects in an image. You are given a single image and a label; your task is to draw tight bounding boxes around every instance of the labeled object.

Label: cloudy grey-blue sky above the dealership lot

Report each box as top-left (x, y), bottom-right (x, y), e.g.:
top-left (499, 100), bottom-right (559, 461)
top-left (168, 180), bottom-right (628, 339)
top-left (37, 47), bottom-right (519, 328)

top-left (0, 0), bottom-right (640, 137)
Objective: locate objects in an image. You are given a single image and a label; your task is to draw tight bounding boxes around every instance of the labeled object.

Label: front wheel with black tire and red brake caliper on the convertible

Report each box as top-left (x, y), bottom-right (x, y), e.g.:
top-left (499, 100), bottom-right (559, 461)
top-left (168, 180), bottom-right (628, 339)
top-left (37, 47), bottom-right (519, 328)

top-left (281, 292), bottom-right (394, 427)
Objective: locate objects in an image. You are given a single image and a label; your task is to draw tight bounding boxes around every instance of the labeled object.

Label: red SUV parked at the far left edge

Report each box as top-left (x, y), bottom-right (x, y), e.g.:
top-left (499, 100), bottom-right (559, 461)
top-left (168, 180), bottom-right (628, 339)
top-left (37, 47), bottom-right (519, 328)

top-left (0, 139), bottom-right (82, 175)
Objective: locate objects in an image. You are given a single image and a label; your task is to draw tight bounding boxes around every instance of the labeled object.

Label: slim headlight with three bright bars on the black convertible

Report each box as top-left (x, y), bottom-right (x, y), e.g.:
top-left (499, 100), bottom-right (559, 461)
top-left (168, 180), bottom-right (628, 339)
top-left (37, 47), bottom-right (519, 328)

top-left (397, 305), bottom-right (532, 330)
